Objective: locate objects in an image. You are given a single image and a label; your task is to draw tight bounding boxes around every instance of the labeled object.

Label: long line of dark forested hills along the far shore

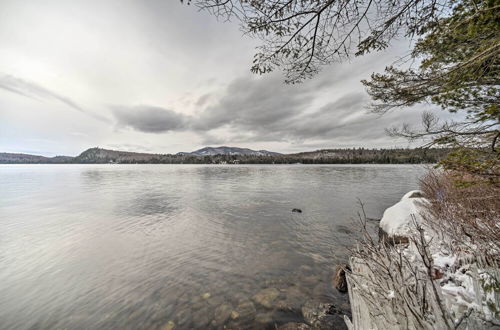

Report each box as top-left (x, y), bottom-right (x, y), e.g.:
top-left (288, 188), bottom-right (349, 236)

top-left (0, 148), bottom-right (448, 164)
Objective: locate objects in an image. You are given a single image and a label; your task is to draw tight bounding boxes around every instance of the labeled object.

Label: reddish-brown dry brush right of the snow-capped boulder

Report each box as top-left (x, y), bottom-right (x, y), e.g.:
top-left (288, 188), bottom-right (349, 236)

top-left (421, 171), bottom-right (500, 264)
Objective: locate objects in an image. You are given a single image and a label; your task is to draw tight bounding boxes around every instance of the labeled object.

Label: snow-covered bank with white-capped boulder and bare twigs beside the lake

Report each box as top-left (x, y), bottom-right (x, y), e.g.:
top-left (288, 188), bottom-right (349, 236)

top-left (346, 191), bottom-right (500, 330)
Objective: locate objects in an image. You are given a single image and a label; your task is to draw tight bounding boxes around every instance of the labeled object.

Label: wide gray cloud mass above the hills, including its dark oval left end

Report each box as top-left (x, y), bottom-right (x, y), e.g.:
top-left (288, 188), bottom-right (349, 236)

top-left (113, 70), bottom-right (442, 146)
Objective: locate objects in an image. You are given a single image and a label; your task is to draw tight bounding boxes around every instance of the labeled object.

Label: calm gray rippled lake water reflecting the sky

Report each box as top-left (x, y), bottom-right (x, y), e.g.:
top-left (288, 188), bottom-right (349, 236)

top-left (0, 165), bottom-right (425, 329)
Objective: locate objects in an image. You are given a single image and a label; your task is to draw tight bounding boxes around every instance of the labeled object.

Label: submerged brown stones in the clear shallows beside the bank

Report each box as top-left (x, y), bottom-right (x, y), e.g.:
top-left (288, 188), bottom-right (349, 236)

top-left (161, 265), bottom-right (350, 330)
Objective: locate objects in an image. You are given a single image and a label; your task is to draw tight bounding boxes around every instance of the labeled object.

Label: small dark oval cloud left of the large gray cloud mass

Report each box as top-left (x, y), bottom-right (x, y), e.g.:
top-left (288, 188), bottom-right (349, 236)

top-left (112, 106), bottom-right (189, 133)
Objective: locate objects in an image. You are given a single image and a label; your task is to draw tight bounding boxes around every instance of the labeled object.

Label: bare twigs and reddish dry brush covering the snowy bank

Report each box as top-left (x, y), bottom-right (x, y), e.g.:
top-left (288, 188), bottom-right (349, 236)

top-left (346, 171), bottom-right (500, 330)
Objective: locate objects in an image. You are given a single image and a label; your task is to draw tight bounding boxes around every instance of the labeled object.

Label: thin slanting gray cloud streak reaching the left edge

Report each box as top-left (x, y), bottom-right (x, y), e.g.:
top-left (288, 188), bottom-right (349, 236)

top-left (0, 75), bottom-right (108, 122)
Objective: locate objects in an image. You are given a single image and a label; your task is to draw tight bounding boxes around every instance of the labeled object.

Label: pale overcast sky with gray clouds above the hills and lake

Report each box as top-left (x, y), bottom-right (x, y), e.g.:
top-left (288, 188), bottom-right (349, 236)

top-left (0, 0), bottom-right (456, 156)
